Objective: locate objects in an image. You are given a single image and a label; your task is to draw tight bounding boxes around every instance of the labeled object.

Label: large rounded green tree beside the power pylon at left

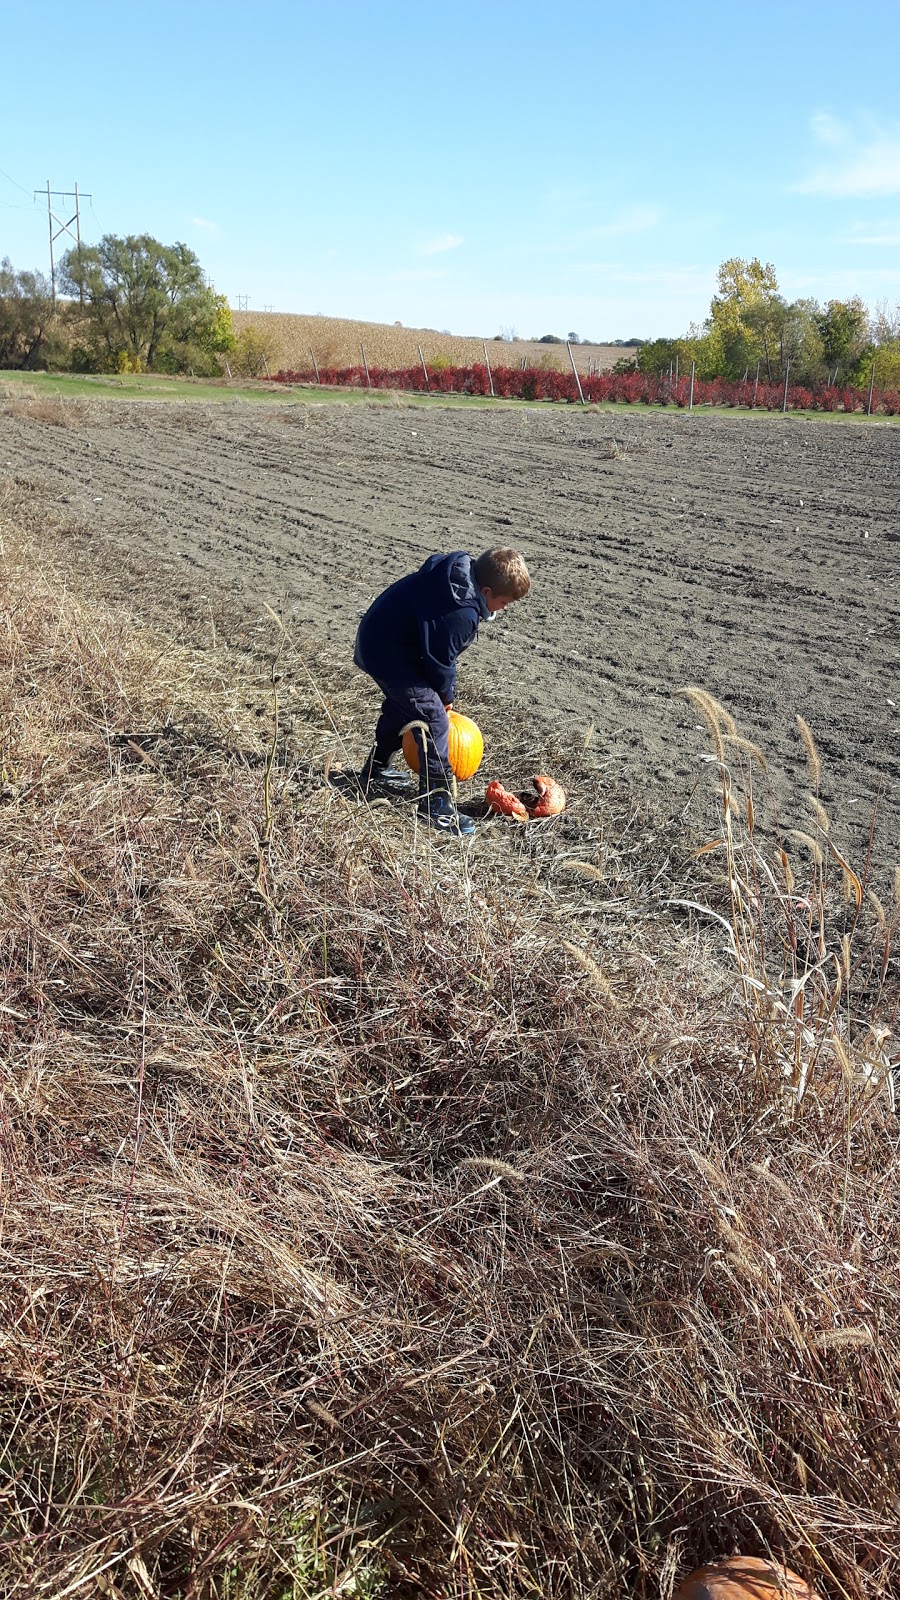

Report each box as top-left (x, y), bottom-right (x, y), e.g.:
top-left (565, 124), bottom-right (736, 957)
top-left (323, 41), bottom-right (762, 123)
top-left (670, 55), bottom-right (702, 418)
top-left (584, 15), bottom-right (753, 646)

top-left (59, 234), bottom-right (234, 371)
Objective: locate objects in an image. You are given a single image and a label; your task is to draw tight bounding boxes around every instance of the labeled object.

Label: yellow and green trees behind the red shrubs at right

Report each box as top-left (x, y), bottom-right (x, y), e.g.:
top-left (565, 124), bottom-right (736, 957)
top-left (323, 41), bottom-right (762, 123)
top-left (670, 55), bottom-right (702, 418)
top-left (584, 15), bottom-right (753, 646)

top-left (618, 256), bottom-right (900, 390)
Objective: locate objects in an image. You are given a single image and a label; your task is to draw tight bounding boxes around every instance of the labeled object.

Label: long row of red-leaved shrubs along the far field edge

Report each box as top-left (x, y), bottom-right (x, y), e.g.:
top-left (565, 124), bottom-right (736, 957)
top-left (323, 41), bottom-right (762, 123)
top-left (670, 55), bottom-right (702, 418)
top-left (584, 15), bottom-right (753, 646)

top-left (267, 363), bottom-right (900, 416)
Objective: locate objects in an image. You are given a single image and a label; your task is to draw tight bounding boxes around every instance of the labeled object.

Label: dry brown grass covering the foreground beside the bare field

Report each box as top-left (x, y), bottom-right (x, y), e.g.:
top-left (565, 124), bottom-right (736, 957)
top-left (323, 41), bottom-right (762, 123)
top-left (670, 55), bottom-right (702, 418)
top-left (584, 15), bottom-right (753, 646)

top-left (0, 473), bottom-right (900, 1600)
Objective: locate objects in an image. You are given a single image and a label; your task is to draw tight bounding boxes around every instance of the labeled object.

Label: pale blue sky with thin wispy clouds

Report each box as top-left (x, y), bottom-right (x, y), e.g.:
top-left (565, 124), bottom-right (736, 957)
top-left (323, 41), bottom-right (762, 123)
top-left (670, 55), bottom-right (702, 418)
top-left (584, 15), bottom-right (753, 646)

top-left (0, 0), bottom-right (900, 339)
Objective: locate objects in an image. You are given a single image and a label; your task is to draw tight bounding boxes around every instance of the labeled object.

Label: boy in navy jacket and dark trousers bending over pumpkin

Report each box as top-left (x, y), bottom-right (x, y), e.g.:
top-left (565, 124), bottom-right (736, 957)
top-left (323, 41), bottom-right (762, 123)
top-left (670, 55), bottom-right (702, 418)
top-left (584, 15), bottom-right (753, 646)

top-left (354, 549), bottom-right (532, 837)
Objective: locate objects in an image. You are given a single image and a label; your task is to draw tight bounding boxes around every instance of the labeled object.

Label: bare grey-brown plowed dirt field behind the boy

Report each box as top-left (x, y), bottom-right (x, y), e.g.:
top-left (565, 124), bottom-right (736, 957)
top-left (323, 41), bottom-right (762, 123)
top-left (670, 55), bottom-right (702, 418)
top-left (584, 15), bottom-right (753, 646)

top-left (0, 403), bottom-right (900, 888)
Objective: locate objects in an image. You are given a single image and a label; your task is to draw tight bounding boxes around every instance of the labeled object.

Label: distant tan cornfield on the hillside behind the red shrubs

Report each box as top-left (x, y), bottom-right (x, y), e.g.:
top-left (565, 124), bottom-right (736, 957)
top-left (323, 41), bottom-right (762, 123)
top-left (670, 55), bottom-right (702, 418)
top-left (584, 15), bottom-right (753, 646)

top-left (232, 310), bottom-right (634, 373)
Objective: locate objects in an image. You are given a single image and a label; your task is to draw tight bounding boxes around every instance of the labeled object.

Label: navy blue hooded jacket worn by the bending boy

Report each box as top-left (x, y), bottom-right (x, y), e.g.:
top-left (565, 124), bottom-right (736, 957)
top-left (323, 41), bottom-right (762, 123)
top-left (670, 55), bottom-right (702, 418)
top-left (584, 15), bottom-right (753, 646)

top-left (354, 550), bottom-right (490, 704)
